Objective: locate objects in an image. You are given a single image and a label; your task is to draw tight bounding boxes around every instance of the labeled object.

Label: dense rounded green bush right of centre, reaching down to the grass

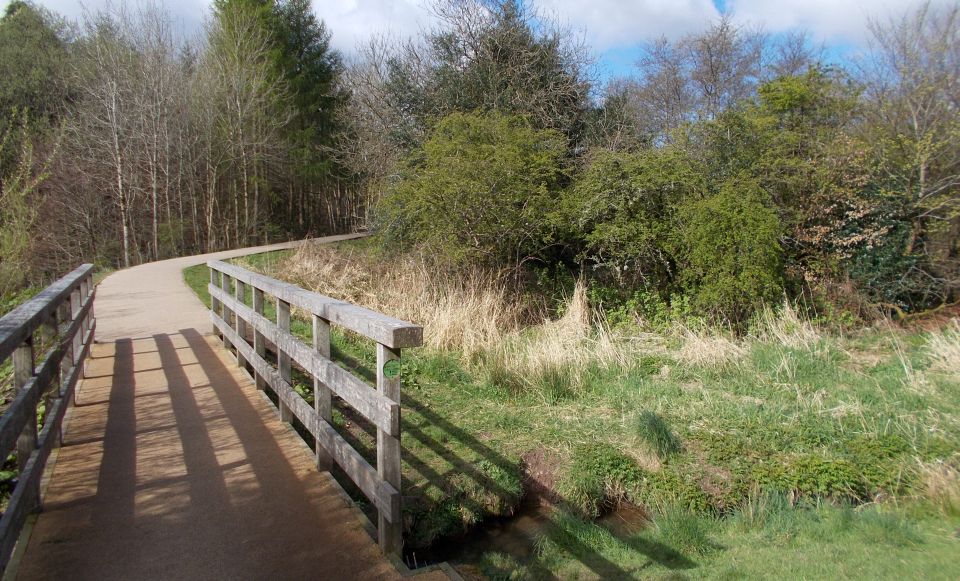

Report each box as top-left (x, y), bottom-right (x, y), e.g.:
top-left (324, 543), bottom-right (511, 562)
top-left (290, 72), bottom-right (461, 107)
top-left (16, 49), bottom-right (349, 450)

top-left (675, 178), bottom-right (783, 324)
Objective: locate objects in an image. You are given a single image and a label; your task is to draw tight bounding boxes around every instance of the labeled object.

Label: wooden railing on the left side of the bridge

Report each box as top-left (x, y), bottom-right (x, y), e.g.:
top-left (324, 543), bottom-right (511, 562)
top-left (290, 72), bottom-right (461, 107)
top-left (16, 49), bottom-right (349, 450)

top-left (0, 264), bottom-right (96, 569)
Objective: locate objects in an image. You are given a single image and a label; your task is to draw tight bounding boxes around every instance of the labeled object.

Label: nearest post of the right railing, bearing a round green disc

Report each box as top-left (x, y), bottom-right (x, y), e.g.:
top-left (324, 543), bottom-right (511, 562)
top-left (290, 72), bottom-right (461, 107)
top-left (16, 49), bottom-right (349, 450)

top-left (377, 343), bottom-right (403, 554)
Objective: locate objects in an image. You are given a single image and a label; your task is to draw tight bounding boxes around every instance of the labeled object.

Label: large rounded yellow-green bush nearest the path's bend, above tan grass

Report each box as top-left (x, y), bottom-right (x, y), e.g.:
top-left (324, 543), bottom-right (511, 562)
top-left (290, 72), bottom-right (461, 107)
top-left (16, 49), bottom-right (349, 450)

top-left (378, 113), bottom-right (566, 266)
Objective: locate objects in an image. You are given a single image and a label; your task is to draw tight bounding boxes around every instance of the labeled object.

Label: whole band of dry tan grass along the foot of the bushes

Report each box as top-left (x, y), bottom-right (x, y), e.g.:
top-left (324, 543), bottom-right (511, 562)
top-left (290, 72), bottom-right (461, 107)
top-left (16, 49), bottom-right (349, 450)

top-left (275, 245), bottom-right (852, 391)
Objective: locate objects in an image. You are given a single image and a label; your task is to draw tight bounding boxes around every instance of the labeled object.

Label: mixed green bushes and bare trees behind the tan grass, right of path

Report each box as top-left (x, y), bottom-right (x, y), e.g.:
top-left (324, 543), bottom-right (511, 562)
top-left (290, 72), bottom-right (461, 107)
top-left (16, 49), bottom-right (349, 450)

top-left (370, 1), bottom-right (960, 327)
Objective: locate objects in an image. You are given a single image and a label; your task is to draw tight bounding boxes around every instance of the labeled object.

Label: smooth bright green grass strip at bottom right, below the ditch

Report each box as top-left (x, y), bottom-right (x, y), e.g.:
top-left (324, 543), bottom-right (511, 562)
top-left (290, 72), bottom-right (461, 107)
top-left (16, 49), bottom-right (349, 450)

top-left (516, 505), bottom-right (960, 579)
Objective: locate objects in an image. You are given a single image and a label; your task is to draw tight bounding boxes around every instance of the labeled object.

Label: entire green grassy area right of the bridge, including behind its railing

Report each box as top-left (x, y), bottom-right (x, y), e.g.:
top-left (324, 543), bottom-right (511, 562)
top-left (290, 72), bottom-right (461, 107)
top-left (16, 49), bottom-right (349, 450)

top-left (185, 242), bottom-right (960, 579)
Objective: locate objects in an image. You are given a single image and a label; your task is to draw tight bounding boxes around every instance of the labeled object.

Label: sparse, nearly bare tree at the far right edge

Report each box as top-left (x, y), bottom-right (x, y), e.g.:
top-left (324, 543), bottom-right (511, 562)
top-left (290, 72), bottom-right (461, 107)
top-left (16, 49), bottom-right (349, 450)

top-left (862, 2), bottom-right (960, 286)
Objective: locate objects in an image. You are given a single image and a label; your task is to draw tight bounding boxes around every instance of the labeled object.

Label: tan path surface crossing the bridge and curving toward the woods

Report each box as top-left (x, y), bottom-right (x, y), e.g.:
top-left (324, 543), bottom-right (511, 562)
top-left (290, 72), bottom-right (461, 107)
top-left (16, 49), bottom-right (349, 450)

top-left (18, 237), bottom-right (445, 580)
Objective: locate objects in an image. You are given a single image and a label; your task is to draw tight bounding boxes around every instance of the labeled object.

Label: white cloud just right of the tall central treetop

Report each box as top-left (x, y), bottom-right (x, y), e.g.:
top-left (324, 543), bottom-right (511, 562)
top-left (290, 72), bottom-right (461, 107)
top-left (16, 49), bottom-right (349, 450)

top-left (532, 0), bottom-right (719, 51)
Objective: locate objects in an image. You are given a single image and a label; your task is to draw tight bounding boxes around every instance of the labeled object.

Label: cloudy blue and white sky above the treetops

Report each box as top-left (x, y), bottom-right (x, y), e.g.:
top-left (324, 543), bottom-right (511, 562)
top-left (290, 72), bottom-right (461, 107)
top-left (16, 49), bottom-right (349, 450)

top-left (9, 0), bottom-right (956, 79)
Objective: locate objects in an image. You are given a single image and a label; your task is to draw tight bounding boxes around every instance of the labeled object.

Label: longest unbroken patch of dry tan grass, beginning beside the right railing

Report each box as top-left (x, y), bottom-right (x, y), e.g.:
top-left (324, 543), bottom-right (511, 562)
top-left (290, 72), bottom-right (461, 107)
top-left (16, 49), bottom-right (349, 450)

top-left (276, 245), bottom-right (644, 390)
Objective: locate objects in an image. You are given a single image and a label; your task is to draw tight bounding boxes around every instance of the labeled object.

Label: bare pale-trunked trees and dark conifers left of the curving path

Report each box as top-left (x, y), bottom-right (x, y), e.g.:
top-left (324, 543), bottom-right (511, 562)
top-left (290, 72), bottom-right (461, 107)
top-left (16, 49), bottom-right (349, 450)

top-left (0, 0), bottom-right (352, 288)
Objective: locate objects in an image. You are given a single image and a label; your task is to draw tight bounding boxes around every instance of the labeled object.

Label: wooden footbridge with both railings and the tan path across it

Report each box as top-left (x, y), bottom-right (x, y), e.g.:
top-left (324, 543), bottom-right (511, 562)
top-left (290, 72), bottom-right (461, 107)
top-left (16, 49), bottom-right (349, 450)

top-left (0, 237), bottom-right (455, 580)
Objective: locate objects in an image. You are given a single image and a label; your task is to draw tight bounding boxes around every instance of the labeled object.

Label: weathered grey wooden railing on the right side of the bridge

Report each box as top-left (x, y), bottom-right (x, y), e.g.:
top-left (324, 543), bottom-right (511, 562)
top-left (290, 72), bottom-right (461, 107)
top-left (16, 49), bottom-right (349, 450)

top-left (207, 261), bottom-right (423, 554)
